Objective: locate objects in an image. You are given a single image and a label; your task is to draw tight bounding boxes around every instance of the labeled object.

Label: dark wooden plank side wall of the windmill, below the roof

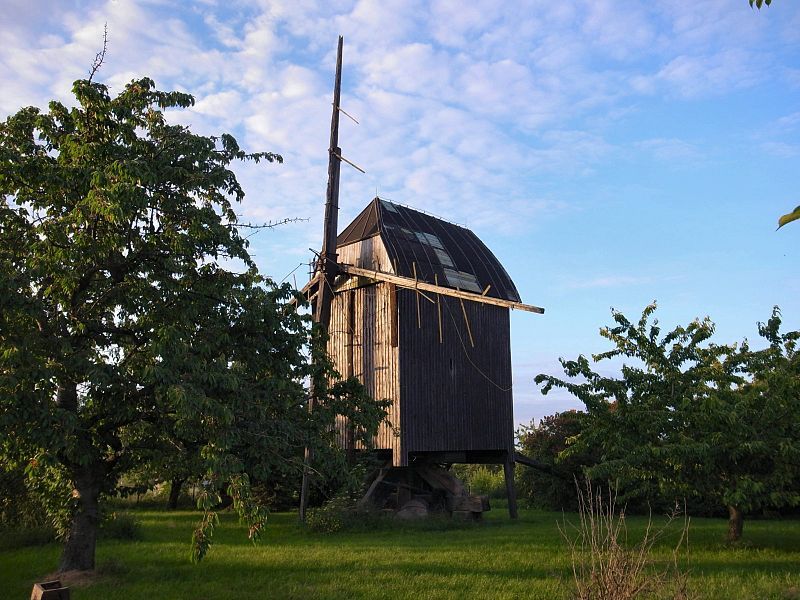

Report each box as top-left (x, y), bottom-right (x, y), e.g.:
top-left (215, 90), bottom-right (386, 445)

top-left (398, 290), bottom-right (514, 453)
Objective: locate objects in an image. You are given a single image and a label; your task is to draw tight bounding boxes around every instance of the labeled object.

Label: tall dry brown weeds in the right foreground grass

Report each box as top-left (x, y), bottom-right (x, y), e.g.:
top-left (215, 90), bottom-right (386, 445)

top-left (559, 481), bottom-right (692, 600)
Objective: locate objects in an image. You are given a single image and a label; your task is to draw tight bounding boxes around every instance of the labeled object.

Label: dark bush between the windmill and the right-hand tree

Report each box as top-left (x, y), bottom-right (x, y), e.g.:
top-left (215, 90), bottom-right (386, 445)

top-left (517, 411), bottom-right (594, 510)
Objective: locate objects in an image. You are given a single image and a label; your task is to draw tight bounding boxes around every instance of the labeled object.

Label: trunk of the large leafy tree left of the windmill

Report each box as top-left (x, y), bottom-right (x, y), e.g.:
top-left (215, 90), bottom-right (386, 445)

top-left (58, 467), bottom-right (100, 572)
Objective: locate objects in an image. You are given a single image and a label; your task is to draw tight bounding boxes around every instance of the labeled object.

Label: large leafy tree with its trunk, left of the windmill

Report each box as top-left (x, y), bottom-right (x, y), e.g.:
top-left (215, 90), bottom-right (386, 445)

top-left (0, 79), bottom-right (388, 570)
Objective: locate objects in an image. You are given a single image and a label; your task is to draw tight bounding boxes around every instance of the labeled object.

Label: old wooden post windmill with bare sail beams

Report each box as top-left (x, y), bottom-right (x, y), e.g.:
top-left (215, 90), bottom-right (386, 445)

top-left (301, 37), bottom-right (544, 517)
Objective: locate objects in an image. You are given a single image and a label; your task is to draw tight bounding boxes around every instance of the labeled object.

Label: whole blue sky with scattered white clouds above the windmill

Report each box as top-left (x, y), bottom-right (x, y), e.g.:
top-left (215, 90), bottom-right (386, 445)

top-left (0, 0), bottom-right (800, 423)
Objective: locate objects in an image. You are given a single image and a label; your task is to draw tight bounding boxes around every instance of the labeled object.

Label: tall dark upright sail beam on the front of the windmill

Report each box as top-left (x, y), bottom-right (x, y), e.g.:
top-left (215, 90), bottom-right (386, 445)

top-left (300, 36), bottom-right (344, 520)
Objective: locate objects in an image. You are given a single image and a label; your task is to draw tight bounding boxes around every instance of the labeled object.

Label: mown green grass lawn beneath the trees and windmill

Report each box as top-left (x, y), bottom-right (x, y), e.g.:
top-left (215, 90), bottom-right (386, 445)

top-left (0, 508), bottom-right (800, 600)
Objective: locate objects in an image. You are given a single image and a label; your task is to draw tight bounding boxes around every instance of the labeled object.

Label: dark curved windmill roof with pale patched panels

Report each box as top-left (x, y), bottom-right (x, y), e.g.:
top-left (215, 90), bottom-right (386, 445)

top-left (336, 198), bottom-right (520, 302)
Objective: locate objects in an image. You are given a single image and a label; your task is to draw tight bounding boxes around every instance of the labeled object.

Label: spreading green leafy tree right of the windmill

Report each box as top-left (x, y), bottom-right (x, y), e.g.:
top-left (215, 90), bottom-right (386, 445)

top-left (536, 304), bottom-right (800, 540)
